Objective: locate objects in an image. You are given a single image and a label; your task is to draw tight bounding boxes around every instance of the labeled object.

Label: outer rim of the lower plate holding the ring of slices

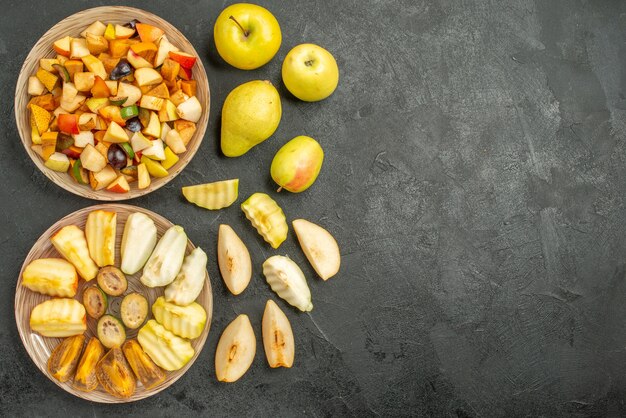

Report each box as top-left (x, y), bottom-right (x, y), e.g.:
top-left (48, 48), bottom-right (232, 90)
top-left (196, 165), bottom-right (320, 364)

top-left (13, 203), bottom-right (214, 404)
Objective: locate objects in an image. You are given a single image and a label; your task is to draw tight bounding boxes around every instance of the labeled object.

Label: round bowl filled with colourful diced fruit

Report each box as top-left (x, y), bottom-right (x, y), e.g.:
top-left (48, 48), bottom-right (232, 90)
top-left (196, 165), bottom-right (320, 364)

top-left (15, 6), bottom-right (210, 201)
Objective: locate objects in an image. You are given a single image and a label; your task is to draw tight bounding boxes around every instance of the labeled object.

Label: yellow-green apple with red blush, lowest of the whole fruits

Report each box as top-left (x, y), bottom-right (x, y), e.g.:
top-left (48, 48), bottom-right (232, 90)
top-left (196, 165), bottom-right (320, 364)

top-left (270, 135), bottom-right (324, 193)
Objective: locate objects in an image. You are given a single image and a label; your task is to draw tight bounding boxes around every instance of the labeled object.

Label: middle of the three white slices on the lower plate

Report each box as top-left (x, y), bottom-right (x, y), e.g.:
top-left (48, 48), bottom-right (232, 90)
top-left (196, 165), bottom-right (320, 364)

top-left (140, 225), bottom-right (187, 287)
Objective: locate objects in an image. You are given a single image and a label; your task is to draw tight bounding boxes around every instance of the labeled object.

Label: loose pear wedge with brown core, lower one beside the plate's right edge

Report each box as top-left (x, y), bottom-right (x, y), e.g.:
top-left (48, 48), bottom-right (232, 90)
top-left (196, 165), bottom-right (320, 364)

top-left (215, 314), bottom-right (256, 382)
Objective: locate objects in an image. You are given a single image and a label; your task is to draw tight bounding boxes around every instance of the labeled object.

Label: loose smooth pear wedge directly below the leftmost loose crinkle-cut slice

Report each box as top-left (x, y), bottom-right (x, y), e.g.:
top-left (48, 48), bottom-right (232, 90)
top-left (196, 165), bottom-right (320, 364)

top-left (217, 224), bottom-right (252, 295)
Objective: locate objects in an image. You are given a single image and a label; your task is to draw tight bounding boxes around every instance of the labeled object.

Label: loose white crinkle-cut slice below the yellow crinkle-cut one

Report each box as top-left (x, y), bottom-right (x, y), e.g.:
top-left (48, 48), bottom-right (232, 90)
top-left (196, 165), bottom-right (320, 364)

top-left (263, 255), bottom-right (313, 312)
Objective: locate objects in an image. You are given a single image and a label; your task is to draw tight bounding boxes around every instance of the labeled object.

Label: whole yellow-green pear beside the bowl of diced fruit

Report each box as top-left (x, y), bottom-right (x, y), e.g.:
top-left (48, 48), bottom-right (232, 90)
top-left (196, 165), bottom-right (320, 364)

top-left (221, 80), bottom-right (282, 157)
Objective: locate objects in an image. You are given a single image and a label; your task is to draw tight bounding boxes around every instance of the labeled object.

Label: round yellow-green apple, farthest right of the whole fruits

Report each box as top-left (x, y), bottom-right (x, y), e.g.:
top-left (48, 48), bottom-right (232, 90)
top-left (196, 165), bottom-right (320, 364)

top-left (282, 44), bottom-right (339, 102)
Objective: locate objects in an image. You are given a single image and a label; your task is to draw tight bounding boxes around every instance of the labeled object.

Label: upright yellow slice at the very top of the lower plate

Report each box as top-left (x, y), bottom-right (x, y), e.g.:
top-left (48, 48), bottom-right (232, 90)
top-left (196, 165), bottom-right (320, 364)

top-left (85, 210), bottom-right (117, 267)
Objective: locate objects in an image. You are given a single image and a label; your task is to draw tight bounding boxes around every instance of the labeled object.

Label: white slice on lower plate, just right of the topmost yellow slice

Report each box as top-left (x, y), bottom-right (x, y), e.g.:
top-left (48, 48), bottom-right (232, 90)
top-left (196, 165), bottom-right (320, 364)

top-left (120, 212), bottom-right (157, 274)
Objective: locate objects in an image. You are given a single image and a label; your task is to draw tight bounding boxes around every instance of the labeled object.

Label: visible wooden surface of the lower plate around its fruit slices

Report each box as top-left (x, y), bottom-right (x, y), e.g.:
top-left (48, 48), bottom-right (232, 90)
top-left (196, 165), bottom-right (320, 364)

top-left (15, 204), bottom-right (213, 403)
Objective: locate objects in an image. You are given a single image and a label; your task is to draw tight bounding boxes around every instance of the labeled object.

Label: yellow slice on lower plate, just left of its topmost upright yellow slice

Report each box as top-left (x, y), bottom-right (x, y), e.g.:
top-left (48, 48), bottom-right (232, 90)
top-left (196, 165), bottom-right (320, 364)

top-left (50, 225), bottom-right (98, 281)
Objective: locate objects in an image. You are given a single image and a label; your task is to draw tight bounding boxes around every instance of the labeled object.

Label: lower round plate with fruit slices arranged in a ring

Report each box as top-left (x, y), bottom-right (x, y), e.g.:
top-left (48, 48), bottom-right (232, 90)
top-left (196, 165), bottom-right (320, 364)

top-left (15, 204), bottom-right (213, 403)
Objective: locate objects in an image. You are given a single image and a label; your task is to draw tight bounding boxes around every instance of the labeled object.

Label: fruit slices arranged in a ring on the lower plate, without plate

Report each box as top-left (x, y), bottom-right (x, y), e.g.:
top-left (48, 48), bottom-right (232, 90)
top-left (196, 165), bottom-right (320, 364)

top-left (22, 209), bottom-right (207, 399)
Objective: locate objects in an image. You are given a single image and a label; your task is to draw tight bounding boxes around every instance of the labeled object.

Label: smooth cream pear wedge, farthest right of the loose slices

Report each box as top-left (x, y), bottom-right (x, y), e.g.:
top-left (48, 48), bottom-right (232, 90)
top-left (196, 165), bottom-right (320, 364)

top-left (292, 219), bottom-right (341, 280)
